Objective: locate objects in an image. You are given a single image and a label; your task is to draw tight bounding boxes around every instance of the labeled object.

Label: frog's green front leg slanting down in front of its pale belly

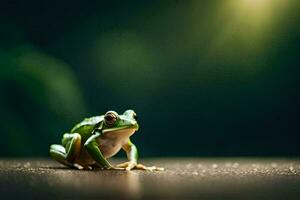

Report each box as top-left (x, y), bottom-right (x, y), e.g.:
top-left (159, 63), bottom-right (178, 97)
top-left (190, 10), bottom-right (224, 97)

top-left (84, 132), bottom-right (117, 169)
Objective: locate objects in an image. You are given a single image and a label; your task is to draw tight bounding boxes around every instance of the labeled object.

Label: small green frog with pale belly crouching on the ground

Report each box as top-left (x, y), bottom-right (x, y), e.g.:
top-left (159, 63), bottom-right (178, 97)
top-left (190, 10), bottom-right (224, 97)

top-left (49, 109), bottom-right (164, 171)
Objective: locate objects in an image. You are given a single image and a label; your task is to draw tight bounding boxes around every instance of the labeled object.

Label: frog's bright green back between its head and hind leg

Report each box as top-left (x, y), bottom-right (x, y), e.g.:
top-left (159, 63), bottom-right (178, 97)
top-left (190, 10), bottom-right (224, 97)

top-left (71, 115), bottom-right (103, 141)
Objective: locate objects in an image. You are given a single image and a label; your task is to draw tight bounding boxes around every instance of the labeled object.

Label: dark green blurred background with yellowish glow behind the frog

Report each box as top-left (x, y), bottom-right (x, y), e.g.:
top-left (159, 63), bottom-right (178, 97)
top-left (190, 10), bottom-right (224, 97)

top-left (0, 0), bottom-right (300, 157)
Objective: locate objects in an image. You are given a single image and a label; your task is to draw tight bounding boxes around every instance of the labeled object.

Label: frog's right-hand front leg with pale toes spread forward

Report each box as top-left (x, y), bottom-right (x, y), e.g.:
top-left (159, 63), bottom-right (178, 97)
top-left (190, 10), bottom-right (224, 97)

top-left (117, 140), bottom-right (164, 171)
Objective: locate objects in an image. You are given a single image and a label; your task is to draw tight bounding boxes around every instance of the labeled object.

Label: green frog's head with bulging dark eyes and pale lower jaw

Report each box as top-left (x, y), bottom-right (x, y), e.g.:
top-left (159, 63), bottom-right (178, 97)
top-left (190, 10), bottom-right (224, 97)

top-left (102, 110), bottom-right (139, 136)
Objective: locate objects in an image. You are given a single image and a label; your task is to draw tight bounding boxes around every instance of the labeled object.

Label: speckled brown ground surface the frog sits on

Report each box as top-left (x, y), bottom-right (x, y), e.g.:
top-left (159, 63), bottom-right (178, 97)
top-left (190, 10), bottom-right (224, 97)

top-left (0, 158), bottom-right (300, 199)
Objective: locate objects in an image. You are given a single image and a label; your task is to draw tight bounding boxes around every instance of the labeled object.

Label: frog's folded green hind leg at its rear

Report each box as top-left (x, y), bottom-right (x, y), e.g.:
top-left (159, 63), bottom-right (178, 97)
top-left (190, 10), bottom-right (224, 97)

top-left (50, 133), bottom-right (81, 168)
